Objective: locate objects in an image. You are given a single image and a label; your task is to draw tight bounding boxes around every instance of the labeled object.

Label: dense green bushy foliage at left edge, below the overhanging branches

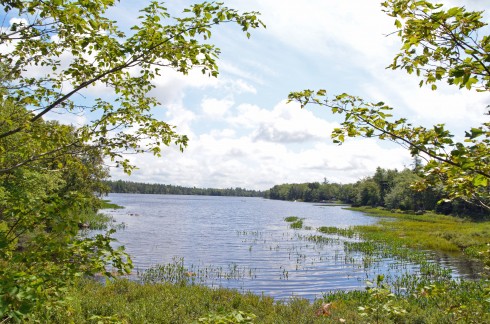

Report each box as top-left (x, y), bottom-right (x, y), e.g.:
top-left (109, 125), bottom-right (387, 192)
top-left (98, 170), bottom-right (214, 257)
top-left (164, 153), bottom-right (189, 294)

top-left (0, 105), bottom-right (131, 321)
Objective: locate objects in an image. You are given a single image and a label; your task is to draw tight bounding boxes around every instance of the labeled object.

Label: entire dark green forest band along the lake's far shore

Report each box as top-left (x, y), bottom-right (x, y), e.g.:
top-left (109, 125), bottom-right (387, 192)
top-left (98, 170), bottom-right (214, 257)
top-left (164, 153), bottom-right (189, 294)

top-left (105, 166), bottom-right (490, 219)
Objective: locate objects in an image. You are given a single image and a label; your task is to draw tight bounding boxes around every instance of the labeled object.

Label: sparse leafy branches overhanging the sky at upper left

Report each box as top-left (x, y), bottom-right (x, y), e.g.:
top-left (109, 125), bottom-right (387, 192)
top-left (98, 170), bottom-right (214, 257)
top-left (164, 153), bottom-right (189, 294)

top-left (0, 0), bottom-right (263, 172)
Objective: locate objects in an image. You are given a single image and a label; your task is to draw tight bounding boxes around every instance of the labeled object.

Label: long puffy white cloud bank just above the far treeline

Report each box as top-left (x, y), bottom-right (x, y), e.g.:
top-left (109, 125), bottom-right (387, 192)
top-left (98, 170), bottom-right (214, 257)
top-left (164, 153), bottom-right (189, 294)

top-left (112, 129), bottom-right (410, 190)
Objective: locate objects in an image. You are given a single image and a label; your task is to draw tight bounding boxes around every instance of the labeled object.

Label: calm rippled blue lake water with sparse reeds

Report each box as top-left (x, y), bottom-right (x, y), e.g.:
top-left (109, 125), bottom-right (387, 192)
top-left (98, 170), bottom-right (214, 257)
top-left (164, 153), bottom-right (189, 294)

top-left (102, 194), bottom-right (478, 299)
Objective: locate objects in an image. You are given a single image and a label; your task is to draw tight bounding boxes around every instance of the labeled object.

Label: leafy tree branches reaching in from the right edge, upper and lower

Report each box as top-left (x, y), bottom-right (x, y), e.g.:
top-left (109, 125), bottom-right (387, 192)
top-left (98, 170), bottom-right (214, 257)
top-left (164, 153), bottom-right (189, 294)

top-left (289, 0), bottom-right (490, 211)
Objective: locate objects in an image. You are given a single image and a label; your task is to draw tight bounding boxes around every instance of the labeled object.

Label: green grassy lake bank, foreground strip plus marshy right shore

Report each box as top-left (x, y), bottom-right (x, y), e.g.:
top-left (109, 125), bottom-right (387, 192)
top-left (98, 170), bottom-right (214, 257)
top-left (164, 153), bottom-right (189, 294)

top-left (38, 196), bottom-right (490, 323)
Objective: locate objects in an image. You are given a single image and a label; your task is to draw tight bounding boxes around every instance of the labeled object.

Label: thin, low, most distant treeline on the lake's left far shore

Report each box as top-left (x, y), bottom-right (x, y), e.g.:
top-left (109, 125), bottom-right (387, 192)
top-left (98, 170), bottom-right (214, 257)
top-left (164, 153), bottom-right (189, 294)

top-left (105, 180), bottom-right (264, 197)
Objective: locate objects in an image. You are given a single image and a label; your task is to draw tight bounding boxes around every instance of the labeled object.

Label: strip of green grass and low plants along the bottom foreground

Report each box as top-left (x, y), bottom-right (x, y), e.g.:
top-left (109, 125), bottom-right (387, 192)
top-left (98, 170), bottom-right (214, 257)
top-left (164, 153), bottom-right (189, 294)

top-left (35, 279), bottom-right (490, 323)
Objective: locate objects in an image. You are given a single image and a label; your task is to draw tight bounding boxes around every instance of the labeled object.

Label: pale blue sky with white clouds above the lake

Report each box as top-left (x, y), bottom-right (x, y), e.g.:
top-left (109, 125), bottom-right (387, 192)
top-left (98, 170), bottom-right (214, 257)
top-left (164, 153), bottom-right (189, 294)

top-left (32, 0), bottom-right (490, 190)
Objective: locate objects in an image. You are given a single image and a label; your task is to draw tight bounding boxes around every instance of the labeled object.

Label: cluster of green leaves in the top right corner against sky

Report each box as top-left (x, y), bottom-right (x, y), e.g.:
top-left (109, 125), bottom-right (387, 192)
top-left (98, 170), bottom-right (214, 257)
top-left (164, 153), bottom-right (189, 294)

top-left (382, 0), bottom-right (490, 91)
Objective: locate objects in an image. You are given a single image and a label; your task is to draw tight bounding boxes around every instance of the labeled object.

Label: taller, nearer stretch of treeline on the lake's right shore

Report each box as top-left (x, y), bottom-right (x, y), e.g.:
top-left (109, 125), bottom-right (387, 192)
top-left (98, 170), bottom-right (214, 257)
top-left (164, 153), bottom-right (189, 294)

top-left (264, 167), bottom-right (490, 218)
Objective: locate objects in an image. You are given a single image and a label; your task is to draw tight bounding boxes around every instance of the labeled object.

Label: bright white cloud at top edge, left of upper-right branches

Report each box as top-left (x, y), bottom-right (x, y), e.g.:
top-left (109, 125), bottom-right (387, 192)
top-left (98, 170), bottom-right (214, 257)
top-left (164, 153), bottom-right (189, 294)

top-left (247, 0), bottom-right (396, 66)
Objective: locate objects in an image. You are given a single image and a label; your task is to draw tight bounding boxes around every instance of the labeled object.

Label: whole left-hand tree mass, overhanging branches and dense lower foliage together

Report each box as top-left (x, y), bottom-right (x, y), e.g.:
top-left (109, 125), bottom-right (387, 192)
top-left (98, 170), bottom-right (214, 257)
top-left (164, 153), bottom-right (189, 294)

top-left (0, 0), bottom-right (263, 323)
